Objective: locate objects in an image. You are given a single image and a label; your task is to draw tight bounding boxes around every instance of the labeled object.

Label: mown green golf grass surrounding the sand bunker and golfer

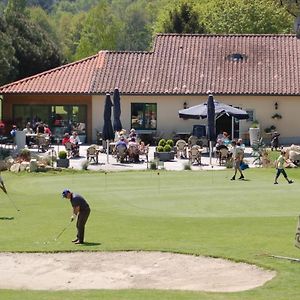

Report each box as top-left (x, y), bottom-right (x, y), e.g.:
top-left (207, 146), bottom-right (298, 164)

top-left (0, 168), bottom-right (300, 300)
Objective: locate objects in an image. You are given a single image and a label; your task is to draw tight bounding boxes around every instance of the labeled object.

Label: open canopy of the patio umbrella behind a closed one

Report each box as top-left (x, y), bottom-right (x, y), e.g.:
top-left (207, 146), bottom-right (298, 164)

top-left (178, 100), bottom-right (249, 120)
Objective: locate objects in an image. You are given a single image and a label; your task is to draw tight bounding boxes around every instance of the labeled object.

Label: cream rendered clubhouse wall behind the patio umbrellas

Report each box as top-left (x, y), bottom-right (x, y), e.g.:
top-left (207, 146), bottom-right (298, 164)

top-left (92, 95), bottom-right (300, 143)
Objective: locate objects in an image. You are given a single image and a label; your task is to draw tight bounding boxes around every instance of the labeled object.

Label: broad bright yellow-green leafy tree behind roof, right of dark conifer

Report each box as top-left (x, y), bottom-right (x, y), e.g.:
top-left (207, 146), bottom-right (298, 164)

top-left (201, 0), bottom-right (293, 34)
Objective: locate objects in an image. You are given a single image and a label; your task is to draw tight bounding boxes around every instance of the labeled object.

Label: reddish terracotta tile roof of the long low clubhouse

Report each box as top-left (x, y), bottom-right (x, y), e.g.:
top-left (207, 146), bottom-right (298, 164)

top-left (0, 34), bottom-right (300, 95)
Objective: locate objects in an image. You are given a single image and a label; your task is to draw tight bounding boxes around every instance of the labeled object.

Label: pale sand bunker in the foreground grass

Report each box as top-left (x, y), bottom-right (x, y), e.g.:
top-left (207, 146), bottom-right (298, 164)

top-left (0, 251), bottom-right (276, 292)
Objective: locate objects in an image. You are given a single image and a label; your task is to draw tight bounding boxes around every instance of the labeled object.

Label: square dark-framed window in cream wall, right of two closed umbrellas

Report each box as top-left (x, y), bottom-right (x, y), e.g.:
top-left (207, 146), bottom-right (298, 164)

top-left (131, 103), bottom-right (157, 130)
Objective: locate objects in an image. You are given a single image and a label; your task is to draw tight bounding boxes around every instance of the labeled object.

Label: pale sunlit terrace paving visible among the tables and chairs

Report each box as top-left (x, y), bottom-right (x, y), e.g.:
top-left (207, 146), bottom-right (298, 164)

top-left (31, 145), bottom-right (254, 171)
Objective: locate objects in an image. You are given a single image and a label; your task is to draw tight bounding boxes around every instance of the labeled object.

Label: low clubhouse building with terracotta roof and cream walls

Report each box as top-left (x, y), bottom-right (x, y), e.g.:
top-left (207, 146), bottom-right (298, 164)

top-left (0, 34), bottom-right (300, 144)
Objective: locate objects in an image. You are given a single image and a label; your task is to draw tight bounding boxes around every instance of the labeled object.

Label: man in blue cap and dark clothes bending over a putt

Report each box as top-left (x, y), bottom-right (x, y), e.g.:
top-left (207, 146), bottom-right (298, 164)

top-left (62, 189), bottom-right (91, 244)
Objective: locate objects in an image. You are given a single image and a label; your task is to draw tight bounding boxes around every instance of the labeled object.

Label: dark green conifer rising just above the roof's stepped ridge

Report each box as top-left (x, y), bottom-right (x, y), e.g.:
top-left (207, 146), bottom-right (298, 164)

top-left (155, 0), bottom-right (205, 33)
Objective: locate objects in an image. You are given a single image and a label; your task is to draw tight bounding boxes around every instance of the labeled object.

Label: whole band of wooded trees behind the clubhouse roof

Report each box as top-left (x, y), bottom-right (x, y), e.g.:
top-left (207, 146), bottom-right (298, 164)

top-left (0, 0), bottom-right (300, 85)
